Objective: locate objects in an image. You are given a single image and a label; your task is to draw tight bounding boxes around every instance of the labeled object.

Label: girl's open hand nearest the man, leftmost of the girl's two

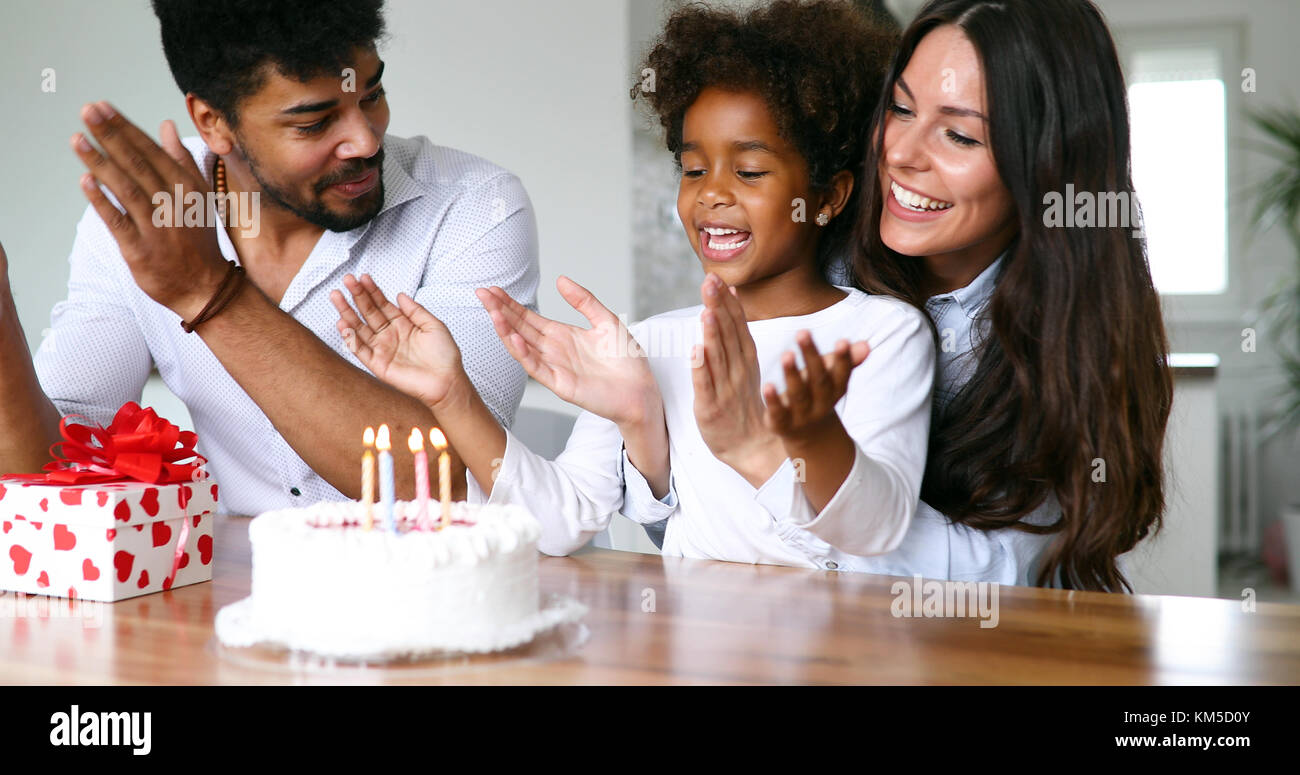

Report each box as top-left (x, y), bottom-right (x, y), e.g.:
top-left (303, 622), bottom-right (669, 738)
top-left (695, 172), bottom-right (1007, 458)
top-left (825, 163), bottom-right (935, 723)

top-left (330, 274), bottom-right (469, 408)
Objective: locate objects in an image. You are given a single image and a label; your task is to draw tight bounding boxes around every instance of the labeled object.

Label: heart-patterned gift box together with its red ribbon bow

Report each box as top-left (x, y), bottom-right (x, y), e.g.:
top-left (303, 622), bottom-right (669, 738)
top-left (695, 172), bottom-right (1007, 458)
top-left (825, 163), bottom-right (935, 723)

top-left (0, 403), bottom-right (217, 602)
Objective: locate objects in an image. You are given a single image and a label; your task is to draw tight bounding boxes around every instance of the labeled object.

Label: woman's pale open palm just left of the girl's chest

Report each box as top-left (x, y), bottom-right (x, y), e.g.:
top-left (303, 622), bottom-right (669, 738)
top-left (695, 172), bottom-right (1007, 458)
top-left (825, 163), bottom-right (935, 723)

top-left (476, 277), bottom-right (663, 428)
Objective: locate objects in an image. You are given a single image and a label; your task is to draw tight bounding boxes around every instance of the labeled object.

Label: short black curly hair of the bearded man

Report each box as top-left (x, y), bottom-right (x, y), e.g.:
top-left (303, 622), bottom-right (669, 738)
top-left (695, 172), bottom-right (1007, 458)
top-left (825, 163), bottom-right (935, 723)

top-left (152, 0), bottom-right (384, 125)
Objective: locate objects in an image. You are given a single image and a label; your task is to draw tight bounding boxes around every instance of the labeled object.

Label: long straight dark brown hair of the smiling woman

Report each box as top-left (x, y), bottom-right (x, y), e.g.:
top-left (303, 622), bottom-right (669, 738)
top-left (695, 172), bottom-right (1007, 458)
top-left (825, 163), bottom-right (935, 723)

top-left (854, 0), bottom-right (1173, 590)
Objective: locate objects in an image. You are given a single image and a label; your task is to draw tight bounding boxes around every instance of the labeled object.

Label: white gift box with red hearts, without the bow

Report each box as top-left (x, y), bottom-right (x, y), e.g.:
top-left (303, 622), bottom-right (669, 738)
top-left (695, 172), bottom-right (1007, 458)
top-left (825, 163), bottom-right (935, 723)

top-left (0, 480), bottom-right (217, 602)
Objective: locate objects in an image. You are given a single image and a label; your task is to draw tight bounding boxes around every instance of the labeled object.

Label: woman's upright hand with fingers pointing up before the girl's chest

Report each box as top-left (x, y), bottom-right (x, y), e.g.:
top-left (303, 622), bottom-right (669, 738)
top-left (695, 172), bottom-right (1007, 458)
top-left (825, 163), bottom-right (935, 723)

top-left (692, 274), bottom-right (785, 488)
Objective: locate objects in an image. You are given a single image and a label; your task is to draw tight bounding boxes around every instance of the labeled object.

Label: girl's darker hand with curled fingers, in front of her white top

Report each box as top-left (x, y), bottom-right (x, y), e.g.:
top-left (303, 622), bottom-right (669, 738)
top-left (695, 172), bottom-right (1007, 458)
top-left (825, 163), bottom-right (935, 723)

top-left (763, 330), bottom-right (871, 441)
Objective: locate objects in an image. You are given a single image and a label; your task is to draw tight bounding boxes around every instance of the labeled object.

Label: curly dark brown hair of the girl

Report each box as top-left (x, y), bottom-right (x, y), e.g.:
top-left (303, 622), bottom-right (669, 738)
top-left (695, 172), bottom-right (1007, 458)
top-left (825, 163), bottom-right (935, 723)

top-left (632, 0), bottom-right (898, 269)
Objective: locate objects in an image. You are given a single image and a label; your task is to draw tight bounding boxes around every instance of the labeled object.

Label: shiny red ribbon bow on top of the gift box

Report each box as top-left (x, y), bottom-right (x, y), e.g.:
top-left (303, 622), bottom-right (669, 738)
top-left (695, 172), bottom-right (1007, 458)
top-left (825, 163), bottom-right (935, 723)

top-left (5, 401), bottom-right (207, 485)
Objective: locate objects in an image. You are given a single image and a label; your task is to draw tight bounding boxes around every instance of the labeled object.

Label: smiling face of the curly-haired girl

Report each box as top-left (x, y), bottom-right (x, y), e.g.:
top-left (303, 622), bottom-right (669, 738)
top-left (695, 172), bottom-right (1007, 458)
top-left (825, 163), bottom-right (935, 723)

top-left (677, 87), bottom-right (852, 292)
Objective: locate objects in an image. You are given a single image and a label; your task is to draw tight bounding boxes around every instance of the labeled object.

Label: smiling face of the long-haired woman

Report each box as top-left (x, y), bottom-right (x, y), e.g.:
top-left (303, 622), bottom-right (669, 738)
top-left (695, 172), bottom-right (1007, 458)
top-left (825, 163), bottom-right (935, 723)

top-left (880, 25), bottom-right (1017, 267)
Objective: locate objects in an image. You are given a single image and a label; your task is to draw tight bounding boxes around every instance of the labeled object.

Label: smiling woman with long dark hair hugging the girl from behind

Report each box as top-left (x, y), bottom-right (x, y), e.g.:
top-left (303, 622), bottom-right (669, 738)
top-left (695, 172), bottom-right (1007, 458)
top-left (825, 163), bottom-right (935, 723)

top-left (855, 0), bottom-right (1173, 590)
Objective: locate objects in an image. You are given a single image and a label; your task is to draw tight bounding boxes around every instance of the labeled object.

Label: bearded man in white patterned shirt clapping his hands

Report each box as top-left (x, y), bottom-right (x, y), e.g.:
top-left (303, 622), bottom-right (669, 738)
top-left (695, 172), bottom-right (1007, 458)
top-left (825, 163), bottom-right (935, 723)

top-left (0, 0), bottom-right (538, 514)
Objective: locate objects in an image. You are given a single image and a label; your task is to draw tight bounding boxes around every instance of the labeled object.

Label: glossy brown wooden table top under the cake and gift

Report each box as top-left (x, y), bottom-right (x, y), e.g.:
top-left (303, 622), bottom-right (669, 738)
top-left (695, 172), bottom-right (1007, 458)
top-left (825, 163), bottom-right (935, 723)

top-left (0, 516), bottom-right (1300, 684)
